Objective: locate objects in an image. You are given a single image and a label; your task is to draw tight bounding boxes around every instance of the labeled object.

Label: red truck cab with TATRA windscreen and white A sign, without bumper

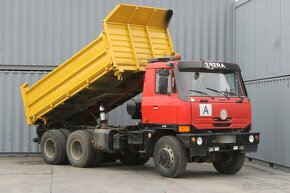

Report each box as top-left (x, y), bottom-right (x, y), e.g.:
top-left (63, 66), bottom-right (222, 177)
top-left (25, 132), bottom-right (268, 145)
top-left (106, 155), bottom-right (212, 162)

top-left (142, 61), bottom-right (251, 130)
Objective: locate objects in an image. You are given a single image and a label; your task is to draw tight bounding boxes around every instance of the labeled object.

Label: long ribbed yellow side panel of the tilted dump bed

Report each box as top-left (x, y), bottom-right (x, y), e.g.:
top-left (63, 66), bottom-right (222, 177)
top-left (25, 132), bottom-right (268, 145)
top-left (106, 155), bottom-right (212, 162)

top-left (22, 35), bottom-right (112, 124)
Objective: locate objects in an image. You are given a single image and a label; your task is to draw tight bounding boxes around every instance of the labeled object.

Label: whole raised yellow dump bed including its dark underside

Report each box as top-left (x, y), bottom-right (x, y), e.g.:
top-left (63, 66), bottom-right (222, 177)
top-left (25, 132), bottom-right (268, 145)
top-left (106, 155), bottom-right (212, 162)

top-left (21, 4), bottom-right (173, 125)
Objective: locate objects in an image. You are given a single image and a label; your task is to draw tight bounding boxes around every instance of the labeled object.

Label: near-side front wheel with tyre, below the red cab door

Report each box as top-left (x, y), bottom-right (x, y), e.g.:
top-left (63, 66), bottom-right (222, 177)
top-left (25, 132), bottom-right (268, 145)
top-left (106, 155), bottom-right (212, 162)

top-left (153, 136), bottom-right (187, 178)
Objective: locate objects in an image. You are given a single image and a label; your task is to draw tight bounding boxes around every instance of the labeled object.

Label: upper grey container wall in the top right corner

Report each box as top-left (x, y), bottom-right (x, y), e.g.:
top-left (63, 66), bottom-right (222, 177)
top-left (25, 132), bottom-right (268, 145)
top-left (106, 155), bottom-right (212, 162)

top-left (234, 0), bottom-right (290, 80)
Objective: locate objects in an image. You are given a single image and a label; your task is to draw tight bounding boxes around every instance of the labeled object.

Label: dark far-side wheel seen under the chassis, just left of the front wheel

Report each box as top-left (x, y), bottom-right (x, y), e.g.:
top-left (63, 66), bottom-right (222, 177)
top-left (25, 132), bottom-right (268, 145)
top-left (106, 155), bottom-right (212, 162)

top-left (119, 153), bottom-right (149, 166)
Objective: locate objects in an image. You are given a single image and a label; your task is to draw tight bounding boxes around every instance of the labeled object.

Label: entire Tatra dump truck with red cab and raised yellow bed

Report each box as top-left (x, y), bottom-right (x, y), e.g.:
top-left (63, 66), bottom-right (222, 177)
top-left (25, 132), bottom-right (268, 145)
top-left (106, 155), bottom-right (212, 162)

top-left (21, 4), bottom-right (259, 177)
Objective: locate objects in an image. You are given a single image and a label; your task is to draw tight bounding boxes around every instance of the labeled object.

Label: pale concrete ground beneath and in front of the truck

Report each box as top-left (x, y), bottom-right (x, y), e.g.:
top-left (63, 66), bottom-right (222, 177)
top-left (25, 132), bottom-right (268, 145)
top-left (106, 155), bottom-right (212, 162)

top-left (0, 157), bottom-right (290, 193)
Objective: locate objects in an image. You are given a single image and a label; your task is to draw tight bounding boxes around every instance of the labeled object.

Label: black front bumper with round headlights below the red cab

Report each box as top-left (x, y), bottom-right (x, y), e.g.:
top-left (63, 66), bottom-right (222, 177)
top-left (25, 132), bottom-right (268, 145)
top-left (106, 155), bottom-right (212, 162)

top-left (176, 132), bottom-right (260, 157)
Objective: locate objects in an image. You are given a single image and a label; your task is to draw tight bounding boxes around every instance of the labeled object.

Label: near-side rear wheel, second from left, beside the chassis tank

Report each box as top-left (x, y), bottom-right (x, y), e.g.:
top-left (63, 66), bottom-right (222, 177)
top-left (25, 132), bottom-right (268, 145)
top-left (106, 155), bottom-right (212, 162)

top-left (66, 130), bottom-right (97, 168)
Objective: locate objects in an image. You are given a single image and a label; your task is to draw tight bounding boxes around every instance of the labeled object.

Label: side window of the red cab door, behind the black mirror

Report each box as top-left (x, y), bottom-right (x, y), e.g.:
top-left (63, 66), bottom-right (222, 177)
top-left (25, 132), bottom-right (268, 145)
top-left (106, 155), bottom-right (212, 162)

top-left (155, 69), bottom-right (171, 94)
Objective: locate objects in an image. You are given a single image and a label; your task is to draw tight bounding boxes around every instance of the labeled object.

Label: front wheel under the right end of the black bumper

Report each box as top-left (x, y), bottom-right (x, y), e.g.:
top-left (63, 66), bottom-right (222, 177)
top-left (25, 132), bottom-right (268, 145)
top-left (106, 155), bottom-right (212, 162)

top-left (213, 151), bottom-right (245, 174)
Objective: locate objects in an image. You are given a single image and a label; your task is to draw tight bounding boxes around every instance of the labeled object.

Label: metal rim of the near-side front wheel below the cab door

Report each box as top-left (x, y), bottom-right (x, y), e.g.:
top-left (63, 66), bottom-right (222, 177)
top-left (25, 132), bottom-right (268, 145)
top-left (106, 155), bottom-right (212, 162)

top-left (158, 145), bottom-right (174, 169)
